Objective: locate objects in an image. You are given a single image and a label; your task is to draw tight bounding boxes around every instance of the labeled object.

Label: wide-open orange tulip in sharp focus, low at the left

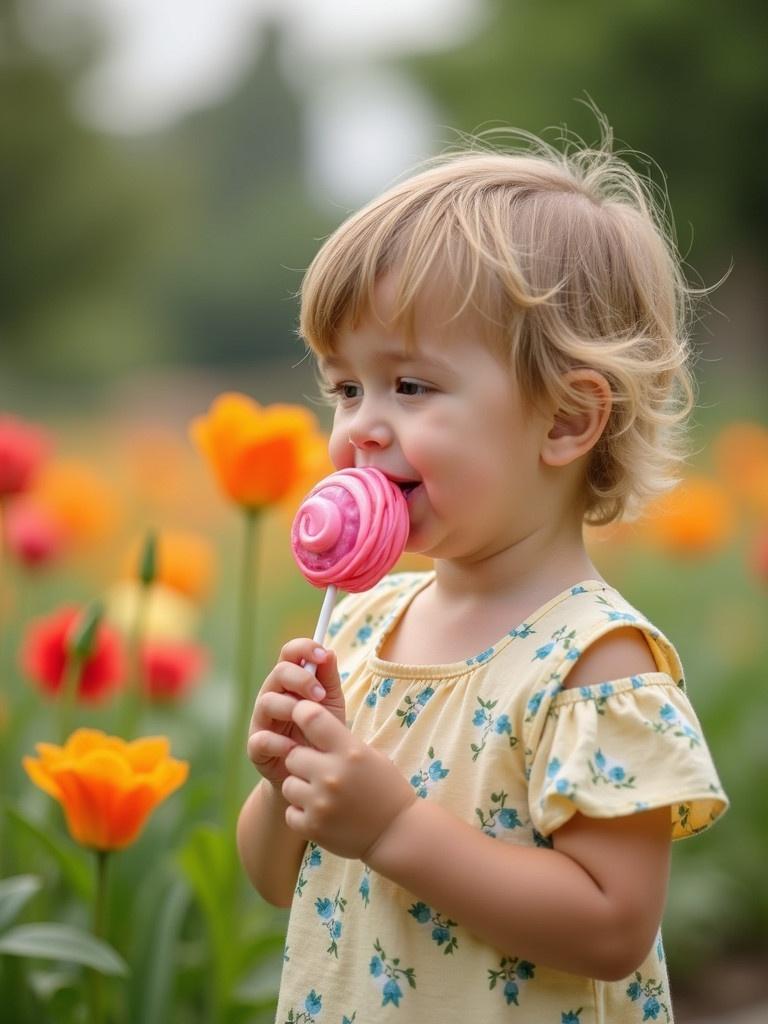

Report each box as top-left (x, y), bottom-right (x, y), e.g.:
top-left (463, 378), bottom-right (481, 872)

top-left (23, 729), bottom-right (188, 851)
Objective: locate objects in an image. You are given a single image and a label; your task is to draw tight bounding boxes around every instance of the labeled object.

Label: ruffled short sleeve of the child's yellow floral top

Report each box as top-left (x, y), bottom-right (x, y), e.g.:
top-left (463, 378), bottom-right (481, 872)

top-left (526, 672), bottom-right (728, 839)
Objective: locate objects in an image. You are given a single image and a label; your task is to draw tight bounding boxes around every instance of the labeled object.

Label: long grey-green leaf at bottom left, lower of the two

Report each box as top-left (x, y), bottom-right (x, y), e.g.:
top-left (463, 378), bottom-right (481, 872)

top-left (0, 922), bottom-right (128, 977)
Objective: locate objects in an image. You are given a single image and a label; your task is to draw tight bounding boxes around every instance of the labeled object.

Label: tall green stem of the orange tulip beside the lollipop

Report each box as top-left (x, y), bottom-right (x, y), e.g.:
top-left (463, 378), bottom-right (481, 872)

top-left (224, 509), bottom-right (259, 836)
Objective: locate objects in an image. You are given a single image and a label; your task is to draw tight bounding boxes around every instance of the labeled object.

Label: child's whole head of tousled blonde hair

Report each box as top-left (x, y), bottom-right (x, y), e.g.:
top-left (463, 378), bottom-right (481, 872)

top-left (299, 123), bottom-right (694, 525)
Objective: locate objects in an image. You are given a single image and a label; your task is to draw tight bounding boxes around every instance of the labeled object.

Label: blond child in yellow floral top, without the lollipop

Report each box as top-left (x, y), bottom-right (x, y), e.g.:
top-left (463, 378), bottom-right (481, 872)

top-left (238, 130), bottom-right (727, 1024)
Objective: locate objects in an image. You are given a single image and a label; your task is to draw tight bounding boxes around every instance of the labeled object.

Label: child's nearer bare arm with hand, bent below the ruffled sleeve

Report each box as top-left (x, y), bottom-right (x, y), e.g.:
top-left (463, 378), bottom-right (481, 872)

top-left (284, 639), bottom-right (670, 980)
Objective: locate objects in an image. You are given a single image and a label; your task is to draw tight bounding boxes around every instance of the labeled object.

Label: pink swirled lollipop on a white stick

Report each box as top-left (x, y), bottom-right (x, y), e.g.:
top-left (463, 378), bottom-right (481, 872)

top-left (291, 468), bottom-right (409, 671)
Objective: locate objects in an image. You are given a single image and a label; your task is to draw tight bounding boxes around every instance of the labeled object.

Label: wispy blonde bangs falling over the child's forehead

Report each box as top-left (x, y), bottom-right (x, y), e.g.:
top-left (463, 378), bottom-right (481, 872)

top-left (299, 156), bottom-right (549, 356)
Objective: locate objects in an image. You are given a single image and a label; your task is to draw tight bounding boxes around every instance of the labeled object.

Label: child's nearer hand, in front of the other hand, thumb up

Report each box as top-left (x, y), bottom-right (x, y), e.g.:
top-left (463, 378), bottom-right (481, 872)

top-left (283, 700), bottom-right (418, 859)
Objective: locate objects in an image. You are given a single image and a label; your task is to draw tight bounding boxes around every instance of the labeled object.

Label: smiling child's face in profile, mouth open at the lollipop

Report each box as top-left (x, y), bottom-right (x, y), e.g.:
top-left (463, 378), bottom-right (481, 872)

top-left (321, 280), bottom-right (547, 560)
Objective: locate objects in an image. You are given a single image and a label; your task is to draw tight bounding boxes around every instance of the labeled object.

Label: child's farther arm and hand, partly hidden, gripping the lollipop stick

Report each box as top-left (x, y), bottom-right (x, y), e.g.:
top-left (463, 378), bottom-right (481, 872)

top-left (238, 639), bottom-right (344, 906)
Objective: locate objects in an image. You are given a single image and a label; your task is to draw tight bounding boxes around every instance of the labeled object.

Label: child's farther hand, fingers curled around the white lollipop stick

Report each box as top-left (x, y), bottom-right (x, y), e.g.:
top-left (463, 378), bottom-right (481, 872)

top-left (248, 638), bottom-right (346, 786)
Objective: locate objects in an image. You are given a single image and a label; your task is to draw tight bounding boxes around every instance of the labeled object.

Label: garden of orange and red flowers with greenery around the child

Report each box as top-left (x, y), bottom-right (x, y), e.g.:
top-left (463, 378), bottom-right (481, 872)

top-left (0, 393), bottom-right (768, 1024)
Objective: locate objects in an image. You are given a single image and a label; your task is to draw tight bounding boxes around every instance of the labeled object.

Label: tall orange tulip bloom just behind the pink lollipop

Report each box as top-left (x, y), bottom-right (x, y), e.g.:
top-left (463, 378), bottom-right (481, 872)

top-left (190, 392), bottom-right (325, 509)
